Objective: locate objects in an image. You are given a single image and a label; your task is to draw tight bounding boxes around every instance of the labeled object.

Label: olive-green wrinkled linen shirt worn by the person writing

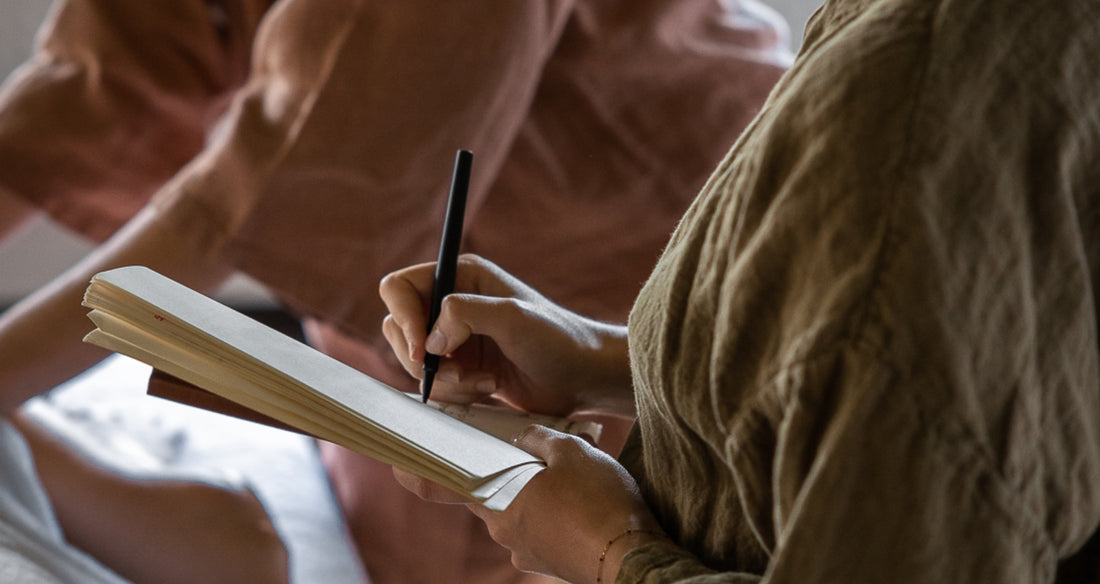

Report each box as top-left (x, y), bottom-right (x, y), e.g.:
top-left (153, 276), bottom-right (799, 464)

top-left (620, 0), bottom-right (1100, 584)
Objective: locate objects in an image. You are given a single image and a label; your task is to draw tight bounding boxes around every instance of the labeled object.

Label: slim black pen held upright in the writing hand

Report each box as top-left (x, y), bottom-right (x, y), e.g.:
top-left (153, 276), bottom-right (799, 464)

top-left (420, 150), bottom-right (474, 404)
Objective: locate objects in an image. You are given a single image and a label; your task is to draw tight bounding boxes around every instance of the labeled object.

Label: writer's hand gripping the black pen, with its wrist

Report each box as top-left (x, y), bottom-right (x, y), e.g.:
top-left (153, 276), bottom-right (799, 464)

top-left (380, 255), bottom-right (635, 417)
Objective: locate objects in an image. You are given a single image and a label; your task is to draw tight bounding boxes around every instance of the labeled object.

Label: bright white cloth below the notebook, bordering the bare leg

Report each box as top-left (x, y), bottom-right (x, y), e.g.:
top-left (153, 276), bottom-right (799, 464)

top-left (21, 355), bottom-right (366, 584)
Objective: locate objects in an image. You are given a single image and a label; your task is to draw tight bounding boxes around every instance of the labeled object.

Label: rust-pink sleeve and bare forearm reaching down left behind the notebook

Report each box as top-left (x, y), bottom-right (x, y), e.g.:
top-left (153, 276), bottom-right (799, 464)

top-left (0, 2), bottom-right (568, 420)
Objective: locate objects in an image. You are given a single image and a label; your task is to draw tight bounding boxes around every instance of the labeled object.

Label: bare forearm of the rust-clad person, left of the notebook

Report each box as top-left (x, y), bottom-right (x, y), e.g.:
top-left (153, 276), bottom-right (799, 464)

top-left (0, 203), bottom-right (230, 414)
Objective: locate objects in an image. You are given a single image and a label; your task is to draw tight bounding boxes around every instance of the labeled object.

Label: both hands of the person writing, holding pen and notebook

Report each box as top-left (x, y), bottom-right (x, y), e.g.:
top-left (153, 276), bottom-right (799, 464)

top-left (380, 255), bottom-right (663, 582)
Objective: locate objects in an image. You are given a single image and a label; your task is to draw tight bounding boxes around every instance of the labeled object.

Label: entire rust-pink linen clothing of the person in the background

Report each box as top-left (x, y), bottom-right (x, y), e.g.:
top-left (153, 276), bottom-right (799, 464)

top-left (0, 0), bottom-right (789, 583)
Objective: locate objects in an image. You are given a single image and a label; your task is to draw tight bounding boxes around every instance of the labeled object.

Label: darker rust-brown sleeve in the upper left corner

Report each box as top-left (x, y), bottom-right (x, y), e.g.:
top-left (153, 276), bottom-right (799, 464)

top-left (0, 0), bottom-right (266, 240)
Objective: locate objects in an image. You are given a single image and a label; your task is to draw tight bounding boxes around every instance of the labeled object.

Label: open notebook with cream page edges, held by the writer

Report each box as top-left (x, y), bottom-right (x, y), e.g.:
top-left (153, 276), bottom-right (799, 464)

top-left (84, 266), bottom-right (597, 509)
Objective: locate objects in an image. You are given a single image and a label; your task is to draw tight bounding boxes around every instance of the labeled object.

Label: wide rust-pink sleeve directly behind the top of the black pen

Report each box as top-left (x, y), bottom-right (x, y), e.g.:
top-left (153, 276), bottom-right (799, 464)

top-left (157, 0), bottom-right (572, 337)
